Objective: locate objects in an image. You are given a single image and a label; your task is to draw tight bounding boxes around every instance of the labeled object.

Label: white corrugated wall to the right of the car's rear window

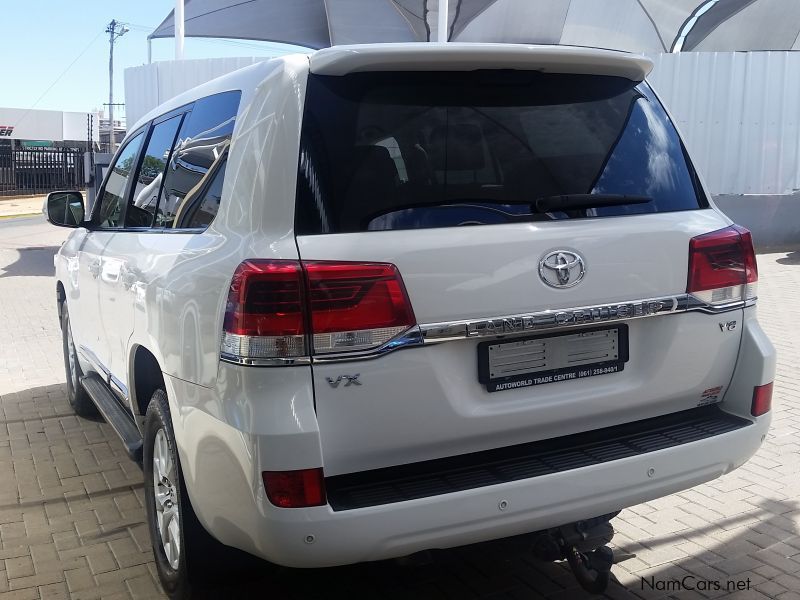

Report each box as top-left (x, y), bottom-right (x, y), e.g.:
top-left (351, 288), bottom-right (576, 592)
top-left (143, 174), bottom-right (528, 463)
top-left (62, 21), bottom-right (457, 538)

top-left (649, 52), bottom-right (800, 195)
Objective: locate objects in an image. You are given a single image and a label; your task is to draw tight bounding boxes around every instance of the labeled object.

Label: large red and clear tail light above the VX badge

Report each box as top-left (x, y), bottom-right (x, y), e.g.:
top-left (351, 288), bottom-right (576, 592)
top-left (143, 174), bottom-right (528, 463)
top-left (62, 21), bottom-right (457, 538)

top-left (221, 260), bottom-right (416, 363)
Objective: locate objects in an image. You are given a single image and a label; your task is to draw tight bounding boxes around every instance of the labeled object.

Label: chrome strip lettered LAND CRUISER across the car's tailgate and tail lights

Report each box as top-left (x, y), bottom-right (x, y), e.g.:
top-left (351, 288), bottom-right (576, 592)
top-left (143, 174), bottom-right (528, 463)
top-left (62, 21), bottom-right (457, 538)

top-left (220, 293), bottom-right (757, 367)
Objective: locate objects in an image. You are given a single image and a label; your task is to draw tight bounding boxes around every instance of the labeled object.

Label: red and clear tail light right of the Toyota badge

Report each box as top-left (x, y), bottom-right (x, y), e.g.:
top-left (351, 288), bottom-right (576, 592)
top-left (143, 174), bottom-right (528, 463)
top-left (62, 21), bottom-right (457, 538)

top-left (686, 225), bottom-right (758, 305)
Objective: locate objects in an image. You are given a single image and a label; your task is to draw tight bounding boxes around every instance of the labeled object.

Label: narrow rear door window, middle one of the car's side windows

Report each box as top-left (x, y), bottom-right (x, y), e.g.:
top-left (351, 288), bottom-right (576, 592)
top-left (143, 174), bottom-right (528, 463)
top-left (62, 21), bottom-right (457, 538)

top-left (125, 115), bottom-right (183, 227)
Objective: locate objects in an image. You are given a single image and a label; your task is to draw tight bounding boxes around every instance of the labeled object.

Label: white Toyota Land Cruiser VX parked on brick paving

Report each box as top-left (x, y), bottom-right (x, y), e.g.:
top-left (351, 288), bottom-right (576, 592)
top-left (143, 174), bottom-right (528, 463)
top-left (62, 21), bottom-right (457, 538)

top-left (48, 43), bottom-right (775, 597)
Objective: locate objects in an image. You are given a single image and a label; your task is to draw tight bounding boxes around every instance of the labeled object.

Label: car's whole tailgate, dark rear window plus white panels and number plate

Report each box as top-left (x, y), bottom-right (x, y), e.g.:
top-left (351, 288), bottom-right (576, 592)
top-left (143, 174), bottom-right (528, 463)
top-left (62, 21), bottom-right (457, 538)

top-left (295, 57), bottom-right (752, 475)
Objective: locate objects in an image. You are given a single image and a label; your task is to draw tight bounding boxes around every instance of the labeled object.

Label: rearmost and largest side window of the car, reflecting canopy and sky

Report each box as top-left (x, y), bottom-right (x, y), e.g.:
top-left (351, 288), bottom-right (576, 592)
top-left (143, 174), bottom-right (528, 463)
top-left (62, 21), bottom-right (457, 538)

top-left (155, 91), bottom-right (241, 229)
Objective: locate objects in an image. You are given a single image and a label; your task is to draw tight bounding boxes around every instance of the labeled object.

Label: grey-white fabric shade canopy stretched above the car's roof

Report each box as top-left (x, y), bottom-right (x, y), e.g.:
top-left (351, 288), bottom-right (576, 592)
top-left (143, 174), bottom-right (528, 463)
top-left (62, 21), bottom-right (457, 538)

top-left (150, 0), bottom-right (800, 52)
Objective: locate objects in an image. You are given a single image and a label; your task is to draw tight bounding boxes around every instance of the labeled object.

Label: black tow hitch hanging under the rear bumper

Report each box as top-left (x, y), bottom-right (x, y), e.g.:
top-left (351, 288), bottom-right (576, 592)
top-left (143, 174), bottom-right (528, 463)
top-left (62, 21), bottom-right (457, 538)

top-left (533, 512), bottom-right (619, 594)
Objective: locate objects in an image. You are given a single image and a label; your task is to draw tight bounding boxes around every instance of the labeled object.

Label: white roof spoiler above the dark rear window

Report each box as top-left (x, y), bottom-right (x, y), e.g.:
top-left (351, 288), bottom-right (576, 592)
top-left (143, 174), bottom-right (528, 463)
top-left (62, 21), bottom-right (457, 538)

top-left (309, 42), bottom-right (653, 82)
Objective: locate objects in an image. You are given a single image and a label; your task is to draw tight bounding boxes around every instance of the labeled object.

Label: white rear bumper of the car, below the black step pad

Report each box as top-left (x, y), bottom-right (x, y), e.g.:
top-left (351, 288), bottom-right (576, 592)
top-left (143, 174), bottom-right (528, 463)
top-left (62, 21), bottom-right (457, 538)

top-left (170, 380), bottom-right (771, 567)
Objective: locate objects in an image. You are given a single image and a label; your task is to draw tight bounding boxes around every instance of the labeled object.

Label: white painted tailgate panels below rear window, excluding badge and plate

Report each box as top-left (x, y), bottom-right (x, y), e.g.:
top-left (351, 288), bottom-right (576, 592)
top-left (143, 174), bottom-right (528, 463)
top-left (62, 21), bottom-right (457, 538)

top-left (298, 210), bottom-right (741, 475)
